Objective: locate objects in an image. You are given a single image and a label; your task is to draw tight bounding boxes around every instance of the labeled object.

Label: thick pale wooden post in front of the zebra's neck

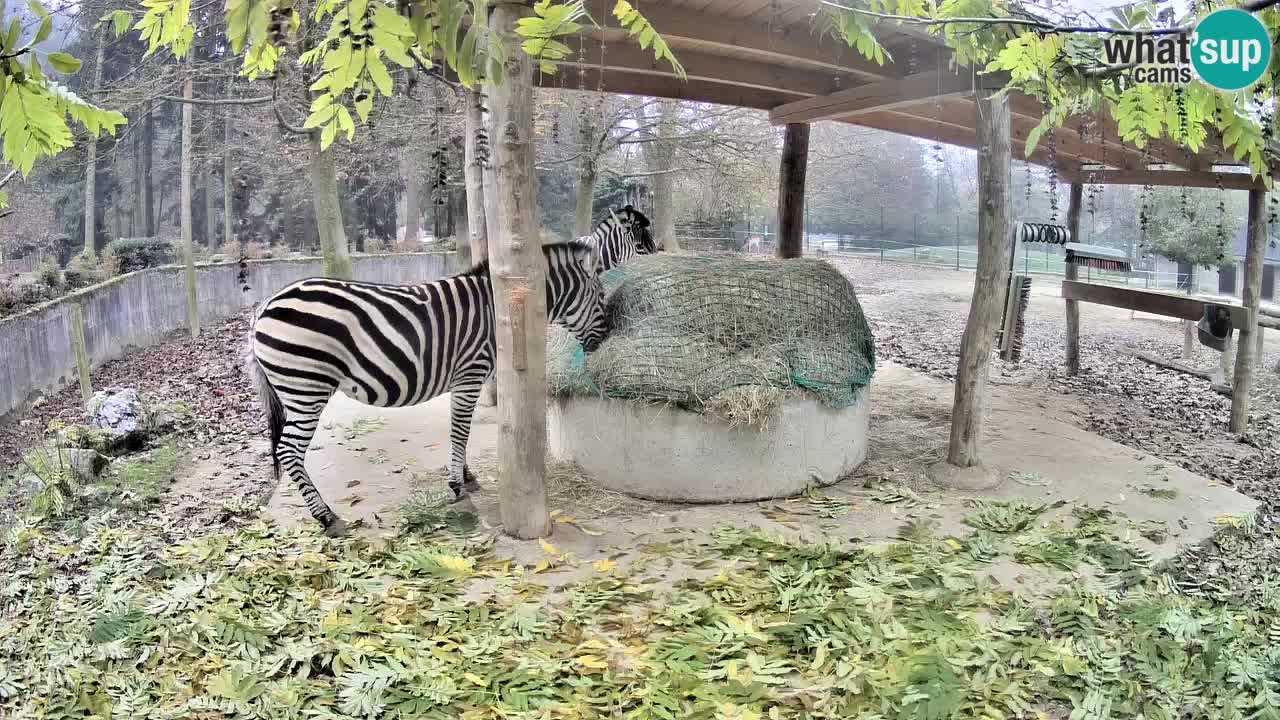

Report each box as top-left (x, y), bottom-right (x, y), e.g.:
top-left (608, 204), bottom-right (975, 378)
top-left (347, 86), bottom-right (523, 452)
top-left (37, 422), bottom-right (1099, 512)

top-left (485, 0), bottom-right (552, 539)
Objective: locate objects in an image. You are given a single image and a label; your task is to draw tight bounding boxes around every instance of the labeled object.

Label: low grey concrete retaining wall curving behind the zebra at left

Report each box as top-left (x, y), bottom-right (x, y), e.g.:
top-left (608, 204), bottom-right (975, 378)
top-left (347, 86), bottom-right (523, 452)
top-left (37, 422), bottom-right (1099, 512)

top-left (0, 252), bottom-right (458, 416)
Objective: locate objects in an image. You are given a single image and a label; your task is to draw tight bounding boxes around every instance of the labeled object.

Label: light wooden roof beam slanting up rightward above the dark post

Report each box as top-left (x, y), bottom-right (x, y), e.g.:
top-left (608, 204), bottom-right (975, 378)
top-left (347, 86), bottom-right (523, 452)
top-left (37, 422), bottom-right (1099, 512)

top-left (769, 70), bottom-right (975, 126)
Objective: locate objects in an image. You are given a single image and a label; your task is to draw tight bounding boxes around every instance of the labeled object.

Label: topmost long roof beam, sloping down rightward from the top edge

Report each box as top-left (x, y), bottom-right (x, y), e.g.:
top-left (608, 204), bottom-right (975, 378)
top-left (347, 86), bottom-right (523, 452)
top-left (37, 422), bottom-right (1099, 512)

top-left (584, 0), bottom-right (902, 82)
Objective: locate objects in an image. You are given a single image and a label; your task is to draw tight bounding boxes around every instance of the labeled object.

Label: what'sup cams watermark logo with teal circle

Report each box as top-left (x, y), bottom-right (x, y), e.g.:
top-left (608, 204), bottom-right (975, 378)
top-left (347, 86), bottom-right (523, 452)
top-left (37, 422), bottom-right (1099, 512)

top-left (1103, 8), bottom-right (1271, 90)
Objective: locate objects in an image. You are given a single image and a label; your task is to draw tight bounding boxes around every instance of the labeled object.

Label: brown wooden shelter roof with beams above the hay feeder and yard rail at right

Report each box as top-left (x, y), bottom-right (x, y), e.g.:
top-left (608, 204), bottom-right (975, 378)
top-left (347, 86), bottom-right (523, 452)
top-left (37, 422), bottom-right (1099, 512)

top-left (539, 0), bottom-right (1261, 188)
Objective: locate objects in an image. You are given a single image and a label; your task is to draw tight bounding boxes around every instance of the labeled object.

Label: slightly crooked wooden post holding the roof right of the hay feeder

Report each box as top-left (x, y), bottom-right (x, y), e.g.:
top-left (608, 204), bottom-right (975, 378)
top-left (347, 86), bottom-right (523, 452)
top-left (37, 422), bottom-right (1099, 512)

top-left (947, 91), bottom-right (1011, 468)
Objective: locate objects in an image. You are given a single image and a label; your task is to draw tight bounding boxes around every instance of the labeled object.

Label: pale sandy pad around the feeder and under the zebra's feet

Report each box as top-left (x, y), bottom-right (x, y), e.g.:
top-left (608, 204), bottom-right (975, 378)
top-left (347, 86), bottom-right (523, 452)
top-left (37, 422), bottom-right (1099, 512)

top-left (269, 363), bottom-right (1254, 592)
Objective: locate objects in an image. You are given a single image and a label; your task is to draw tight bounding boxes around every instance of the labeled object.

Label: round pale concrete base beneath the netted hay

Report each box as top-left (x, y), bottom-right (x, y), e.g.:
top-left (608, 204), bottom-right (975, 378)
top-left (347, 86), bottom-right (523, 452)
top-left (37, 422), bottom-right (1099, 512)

top-left (548, 388), bottom-right (870, 502)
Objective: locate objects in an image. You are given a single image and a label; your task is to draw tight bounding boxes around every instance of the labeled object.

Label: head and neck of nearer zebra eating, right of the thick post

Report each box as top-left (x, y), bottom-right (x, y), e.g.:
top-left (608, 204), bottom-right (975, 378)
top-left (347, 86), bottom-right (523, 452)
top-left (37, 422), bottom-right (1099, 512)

top-left (543, 242), bottom-right (609, 352)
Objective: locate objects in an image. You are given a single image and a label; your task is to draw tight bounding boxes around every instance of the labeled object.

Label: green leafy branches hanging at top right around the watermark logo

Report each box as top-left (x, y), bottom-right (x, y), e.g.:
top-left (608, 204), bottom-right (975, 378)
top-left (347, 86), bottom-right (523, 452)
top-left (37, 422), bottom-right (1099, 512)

top-left (822, 0), bottom-right (1280, 184)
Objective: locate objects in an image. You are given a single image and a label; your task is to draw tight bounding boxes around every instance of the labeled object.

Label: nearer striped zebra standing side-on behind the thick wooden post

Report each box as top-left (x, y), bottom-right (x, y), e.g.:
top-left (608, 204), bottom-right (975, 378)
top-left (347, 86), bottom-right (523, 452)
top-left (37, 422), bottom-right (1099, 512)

top-left (250, 242), bottom-right (607, 536)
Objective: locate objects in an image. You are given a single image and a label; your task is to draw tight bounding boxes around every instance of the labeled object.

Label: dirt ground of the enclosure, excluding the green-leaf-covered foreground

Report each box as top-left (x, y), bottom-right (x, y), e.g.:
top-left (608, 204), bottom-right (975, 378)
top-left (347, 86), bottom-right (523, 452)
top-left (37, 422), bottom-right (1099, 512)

top-left (0, 259), bottom-right (1280, 584)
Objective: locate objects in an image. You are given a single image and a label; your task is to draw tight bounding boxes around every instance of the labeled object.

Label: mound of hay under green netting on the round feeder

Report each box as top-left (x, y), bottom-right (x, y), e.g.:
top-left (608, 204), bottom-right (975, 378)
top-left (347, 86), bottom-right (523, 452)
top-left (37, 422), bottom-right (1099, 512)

top-left (548, 255), bottom-right (876, 424)
